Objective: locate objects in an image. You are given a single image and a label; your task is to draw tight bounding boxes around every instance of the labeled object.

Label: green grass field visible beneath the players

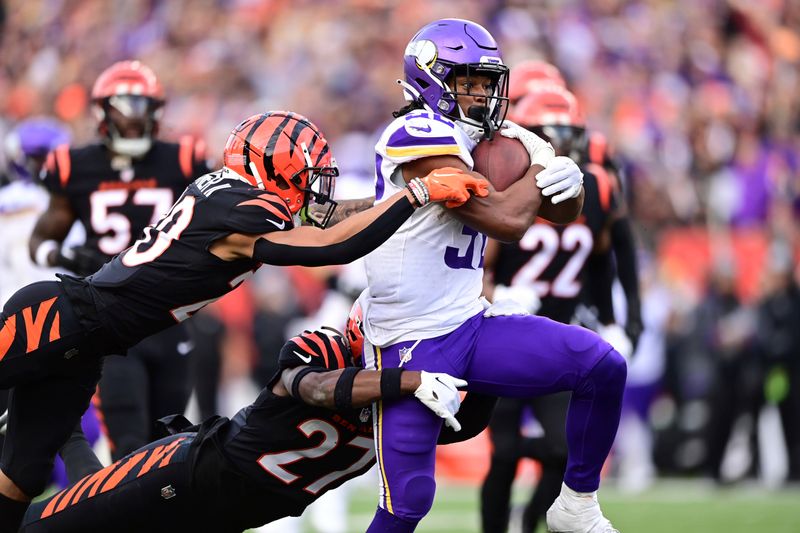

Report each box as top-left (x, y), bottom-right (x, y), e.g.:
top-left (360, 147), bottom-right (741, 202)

top-left (328, 481), bottom-right (800, 533)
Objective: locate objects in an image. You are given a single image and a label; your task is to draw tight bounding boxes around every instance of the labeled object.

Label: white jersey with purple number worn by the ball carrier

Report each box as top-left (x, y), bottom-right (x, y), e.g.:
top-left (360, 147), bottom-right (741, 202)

top-left (360, 111), bottom-right (486, 346)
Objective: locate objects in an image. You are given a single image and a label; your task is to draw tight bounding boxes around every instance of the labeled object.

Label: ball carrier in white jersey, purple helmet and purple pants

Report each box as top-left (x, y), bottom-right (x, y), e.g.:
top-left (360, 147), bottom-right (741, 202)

top-left (360, 19), bottom-right (626, 533)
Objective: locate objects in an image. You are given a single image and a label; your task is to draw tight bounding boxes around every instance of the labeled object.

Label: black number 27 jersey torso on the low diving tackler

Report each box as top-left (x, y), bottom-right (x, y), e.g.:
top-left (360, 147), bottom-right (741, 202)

top-left (195, 388), bottom-right (375, 528)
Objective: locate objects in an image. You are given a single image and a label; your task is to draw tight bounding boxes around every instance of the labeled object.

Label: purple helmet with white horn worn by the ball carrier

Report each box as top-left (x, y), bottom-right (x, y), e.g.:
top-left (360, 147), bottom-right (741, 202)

top-left (402, 19), bottom-right (508, 137)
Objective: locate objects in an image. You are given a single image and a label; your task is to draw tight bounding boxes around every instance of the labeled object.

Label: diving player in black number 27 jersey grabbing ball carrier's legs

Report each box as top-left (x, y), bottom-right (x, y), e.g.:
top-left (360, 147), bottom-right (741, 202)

top-left (15, 328), bottom-right (488, 533)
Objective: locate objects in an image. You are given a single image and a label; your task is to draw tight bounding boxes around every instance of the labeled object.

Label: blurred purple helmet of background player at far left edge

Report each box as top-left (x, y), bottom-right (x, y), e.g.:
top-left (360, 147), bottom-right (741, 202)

top-left (4, 118), bottom-right (70, 180)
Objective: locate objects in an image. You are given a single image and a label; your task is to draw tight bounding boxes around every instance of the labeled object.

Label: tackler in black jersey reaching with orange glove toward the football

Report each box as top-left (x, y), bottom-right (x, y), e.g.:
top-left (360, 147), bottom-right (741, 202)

top-left (0, 111), bottom-right (488, 531)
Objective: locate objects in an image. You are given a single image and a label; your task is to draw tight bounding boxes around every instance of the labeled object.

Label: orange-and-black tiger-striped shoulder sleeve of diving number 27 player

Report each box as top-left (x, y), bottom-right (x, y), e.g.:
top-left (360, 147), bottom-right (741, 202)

top-left (278, 327), bottom-right (353, 370)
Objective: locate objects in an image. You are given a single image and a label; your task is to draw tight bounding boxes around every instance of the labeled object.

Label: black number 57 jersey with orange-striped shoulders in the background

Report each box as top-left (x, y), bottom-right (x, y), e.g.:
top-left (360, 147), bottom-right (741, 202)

top-left (43, 137), bottom-right (209, 258)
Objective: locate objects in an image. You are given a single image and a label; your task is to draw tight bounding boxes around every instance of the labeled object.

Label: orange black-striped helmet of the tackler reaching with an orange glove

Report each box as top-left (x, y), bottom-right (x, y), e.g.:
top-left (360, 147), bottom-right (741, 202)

top-left (223, 111), bottom-right (339, 227)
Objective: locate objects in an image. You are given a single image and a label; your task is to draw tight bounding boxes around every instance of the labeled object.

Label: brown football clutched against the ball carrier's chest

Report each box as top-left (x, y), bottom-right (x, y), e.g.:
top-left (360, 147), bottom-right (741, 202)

top-left (472, 134), bottom-right (531, 191)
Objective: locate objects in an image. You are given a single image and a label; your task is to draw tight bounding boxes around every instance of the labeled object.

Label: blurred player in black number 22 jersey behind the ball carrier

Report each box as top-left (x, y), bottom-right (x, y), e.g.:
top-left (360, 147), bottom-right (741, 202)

top-left (481, 84), bottom-right (630, 533)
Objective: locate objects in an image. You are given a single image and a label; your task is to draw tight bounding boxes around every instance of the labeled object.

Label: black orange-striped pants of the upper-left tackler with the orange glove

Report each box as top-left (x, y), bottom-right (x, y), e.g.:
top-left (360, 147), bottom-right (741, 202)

top-left (0, 281), bottom-right (102, 497)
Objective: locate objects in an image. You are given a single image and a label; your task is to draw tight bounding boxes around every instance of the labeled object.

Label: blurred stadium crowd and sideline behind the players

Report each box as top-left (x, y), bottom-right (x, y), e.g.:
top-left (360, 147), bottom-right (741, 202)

top-left (0, 0), bottom-right (800, 524)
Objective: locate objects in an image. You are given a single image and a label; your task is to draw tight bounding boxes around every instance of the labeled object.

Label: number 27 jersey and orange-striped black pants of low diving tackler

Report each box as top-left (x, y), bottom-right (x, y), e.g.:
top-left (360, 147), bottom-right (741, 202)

top-left (21, 389), bottom-right (375, 533)
